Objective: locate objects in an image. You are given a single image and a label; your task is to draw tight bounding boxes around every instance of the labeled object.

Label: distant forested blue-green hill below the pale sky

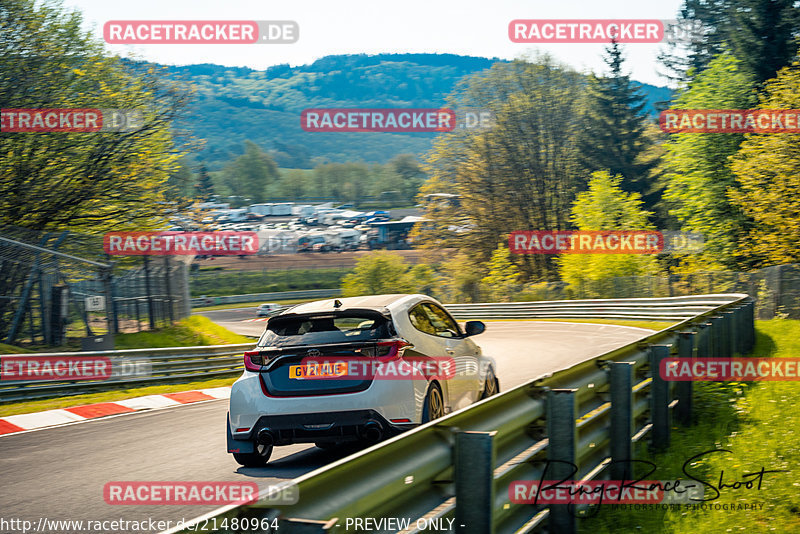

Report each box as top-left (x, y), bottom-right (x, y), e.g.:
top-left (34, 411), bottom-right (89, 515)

top-left (142, 54), bottom-right (671, 170)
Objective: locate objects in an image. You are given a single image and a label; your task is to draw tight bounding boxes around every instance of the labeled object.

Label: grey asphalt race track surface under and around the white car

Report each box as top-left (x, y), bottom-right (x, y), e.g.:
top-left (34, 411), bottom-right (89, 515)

top-left (0, 307), bottom-right (651, 532)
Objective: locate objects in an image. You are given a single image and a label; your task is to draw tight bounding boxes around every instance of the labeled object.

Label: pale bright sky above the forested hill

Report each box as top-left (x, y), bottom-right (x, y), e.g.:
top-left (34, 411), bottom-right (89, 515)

top-left (64, 0), bottom-right (682, 85)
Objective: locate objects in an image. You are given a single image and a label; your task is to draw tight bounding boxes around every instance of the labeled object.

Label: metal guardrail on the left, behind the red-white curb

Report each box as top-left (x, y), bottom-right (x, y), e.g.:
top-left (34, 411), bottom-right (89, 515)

top-left (0, 343), bottom-right (253, 403)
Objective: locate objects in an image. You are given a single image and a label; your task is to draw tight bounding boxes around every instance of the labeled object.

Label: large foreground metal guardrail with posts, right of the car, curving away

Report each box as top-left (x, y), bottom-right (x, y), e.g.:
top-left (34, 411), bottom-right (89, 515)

top-left (167, 294), bottom-right (755, 534)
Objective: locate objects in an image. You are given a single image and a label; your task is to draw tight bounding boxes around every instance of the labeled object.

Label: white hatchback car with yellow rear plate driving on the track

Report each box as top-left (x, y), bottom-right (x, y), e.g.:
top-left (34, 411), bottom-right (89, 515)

top-left (228, 295), bottom-right (500, 467)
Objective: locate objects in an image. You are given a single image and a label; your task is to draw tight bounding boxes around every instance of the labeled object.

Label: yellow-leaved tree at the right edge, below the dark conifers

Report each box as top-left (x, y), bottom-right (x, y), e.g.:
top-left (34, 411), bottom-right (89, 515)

top-left (728, 63), bottom-right (800, 267)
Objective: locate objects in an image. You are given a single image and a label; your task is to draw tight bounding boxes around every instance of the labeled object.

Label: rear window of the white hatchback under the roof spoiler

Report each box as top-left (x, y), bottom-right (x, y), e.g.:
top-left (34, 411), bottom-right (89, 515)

top-left (258, 314), bottom-right (391, 347)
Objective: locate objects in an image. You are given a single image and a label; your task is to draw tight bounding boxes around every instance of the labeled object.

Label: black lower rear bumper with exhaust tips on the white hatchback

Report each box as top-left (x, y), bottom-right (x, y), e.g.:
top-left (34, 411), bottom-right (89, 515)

top-left (235, 410), bottom-right (416, 445)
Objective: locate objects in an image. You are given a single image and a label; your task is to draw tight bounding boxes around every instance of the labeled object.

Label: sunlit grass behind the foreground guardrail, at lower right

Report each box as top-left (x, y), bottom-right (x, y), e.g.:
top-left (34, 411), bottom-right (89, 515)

top-left (580, 319), bottom-right (800, 534)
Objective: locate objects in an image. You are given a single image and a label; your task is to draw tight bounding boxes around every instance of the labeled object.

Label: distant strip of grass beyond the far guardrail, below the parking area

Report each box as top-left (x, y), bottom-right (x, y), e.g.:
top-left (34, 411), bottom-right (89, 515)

top-left (189, 268), bottom-right (352, 297)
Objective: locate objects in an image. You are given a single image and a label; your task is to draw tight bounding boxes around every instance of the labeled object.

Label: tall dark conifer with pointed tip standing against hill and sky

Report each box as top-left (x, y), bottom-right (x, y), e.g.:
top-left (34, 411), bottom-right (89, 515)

top-left (579, 41), bottom-right (660, 207)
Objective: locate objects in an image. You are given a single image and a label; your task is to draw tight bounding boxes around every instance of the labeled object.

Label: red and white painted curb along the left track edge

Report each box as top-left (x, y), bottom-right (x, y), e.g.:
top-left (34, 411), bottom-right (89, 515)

top-left (0, 387), bottom-right (231, 435)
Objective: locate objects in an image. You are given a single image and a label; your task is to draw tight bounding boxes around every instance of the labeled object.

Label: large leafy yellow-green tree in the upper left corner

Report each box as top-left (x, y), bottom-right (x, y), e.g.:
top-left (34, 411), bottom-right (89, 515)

top-left (0, 0), bottom-right (188, 232)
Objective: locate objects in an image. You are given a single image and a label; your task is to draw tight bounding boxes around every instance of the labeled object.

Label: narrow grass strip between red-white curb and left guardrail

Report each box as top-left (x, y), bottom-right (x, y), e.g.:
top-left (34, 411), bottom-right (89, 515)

top-left (0, 377), bottom-right (236, 417)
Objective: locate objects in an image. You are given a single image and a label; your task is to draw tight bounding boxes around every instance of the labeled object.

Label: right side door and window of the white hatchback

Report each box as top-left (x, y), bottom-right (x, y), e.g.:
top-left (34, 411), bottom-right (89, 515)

top-left (422, 302), bottom-right (480, 410)
